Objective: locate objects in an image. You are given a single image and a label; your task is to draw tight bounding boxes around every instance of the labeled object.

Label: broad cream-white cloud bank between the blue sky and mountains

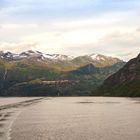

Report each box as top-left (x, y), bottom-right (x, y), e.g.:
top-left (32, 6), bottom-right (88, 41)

top-left (0, 9), bottom-right (140, 60)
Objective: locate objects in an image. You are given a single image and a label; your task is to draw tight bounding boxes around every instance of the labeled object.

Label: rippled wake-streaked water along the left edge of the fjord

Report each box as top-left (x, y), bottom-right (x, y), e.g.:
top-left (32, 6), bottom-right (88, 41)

top-left (0, 97), bottom-right (43, 140)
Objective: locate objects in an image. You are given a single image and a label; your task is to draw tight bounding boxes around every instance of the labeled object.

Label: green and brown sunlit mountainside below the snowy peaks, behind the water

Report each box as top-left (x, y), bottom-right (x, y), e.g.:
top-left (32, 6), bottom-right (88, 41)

top-left (0, 52), bottom-right (125, 96)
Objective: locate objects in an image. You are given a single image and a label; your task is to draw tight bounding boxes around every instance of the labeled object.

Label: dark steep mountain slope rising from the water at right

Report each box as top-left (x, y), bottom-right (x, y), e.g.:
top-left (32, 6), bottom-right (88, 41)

top-left (98, 55), bottom-right (140, 97)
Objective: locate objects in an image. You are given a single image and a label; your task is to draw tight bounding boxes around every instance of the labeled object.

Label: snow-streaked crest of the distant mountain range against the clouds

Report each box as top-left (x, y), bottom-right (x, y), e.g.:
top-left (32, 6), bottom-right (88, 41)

top-left (0, 50), bottom-right (123, 65)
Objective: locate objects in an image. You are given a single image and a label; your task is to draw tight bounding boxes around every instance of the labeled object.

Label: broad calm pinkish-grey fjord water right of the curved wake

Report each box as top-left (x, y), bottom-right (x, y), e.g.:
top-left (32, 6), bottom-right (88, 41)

top-left (6, 97), bottom-right (140, 140)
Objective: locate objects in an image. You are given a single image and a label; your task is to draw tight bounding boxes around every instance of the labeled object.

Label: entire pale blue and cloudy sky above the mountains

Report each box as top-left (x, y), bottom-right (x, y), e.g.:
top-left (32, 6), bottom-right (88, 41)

top-left (0, 0), bottom-right (140, 61)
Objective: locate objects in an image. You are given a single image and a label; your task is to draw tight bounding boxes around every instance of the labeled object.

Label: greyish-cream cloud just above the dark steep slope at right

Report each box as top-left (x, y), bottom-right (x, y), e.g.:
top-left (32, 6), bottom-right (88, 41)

top-left (92, 29), bottom-right (140, 61)
